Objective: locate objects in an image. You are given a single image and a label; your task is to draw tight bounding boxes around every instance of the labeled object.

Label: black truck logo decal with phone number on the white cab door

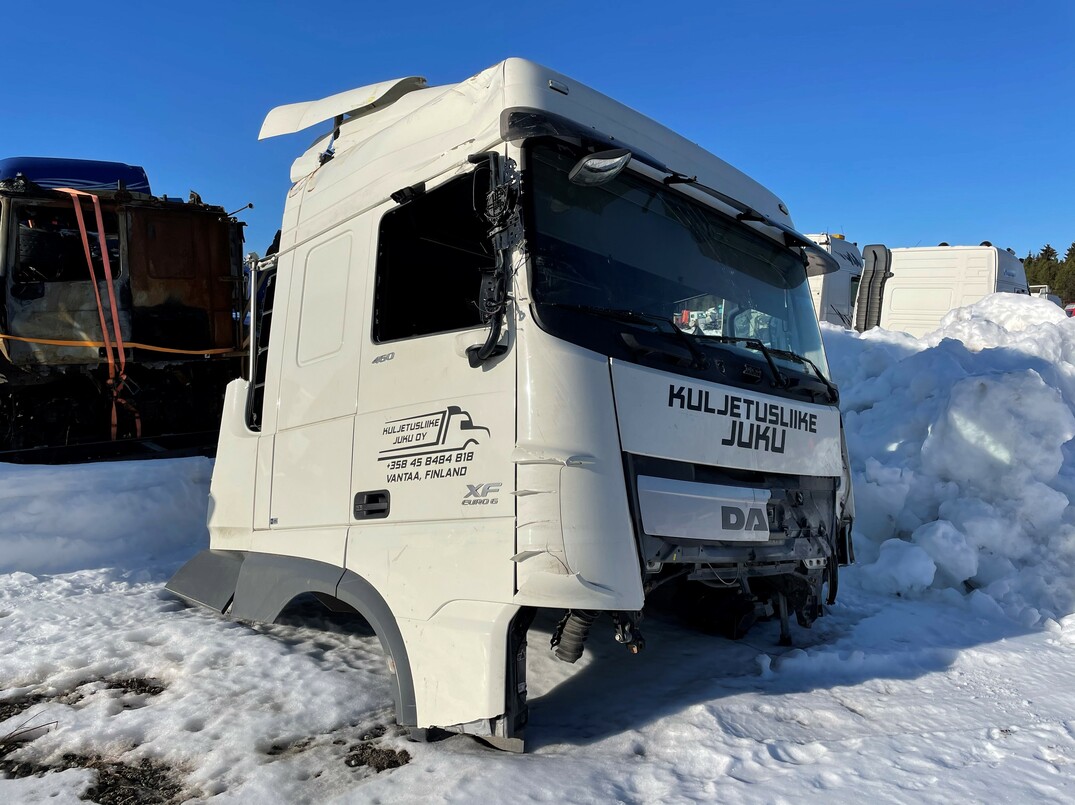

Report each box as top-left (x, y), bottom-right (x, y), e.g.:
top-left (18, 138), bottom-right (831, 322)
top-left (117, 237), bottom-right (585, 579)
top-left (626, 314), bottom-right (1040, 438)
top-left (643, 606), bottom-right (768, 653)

top-left (377, 405), bottom-right (489, 486)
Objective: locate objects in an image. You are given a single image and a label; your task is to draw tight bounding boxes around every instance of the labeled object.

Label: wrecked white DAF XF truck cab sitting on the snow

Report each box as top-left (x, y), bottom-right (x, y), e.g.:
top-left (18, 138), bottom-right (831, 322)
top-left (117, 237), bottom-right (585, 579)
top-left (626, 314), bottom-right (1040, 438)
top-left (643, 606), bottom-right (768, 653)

top-left (169, 59), bottom-right (854, 749)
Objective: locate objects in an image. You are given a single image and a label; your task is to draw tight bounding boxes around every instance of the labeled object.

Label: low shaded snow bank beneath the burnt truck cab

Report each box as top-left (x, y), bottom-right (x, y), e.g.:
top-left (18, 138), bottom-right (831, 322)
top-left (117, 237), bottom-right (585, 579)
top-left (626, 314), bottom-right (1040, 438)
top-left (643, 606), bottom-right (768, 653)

top-left (0, 458), bottom-right (213, 573)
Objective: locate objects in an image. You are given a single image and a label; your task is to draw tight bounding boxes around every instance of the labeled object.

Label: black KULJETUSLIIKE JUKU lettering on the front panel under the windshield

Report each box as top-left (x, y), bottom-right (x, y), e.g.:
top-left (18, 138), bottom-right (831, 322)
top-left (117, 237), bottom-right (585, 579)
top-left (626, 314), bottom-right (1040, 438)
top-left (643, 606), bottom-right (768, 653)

top-left (669, 384), bottom-right (817, 452)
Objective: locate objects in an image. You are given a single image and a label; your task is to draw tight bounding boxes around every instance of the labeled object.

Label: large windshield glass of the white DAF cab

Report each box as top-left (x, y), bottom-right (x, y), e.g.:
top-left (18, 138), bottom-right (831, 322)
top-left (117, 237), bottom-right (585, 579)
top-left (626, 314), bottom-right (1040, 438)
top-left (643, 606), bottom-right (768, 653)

top-left (528, 141), bottom-right (828, 373)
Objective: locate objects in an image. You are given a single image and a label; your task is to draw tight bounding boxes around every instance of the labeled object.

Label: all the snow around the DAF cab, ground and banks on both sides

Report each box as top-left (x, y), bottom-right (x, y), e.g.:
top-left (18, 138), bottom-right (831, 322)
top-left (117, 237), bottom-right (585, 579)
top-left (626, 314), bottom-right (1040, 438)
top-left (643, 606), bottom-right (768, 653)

top-left (0, 297), bottom-right (1075, 803)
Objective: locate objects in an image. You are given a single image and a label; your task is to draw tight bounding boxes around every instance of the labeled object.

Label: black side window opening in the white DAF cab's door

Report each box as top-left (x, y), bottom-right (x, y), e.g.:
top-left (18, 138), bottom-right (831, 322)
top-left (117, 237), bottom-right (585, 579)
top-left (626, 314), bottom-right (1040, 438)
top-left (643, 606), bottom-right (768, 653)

top-left (373, 175), bottom-right (495, 343)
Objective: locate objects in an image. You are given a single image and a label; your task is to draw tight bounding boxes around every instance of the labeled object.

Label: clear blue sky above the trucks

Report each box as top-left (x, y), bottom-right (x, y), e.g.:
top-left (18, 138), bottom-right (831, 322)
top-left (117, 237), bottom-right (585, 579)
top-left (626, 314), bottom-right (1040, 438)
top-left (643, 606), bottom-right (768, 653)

top-left (0, 0), bottom-right (1075, 256)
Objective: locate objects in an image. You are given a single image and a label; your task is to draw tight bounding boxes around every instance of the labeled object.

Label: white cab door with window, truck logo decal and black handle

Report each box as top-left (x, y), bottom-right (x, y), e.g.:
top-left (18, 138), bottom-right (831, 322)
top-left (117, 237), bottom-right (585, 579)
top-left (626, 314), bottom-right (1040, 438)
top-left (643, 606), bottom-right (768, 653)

top-left (347, 174), bottom-right (516, 619)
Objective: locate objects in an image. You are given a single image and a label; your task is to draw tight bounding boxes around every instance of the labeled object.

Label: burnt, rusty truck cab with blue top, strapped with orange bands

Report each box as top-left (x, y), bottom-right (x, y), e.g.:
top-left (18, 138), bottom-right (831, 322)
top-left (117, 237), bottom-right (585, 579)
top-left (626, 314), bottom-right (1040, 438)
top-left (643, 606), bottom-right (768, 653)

top-left (0, 157), bottom-right (245, 461)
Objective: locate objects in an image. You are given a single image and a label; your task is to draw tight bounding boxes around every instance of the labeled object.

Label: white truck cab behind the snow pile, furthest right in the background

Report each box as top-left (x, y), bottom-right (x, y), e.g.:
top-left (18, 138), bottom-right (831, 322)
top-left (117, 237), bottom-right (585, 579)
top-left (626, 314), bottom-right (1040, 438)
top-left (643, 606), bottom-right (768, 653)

top-left (856, 243), bottom-right (1030, 336)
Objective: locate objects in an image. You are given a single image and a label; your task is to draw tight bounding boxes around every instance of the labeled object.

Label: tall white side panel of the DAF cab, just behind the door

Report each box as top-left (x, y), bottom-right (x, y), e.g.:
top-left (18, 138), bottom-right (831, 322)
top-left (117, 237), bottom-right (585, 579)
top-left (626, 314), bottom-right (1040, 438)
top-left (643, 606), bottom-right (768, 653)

top-left (258, 219), bottom-right (369, 566)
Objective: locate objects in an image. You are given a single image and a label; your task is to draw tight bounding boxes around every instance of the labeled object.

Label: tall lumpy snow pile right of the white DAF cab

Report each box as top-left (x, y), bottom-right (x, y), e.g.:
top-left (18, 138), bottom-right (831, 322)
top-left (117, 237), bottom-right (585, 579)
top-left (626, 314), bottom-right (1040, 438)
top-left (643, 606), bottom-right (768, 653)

top-left (822, 293), bottom-right (1075, 626)
